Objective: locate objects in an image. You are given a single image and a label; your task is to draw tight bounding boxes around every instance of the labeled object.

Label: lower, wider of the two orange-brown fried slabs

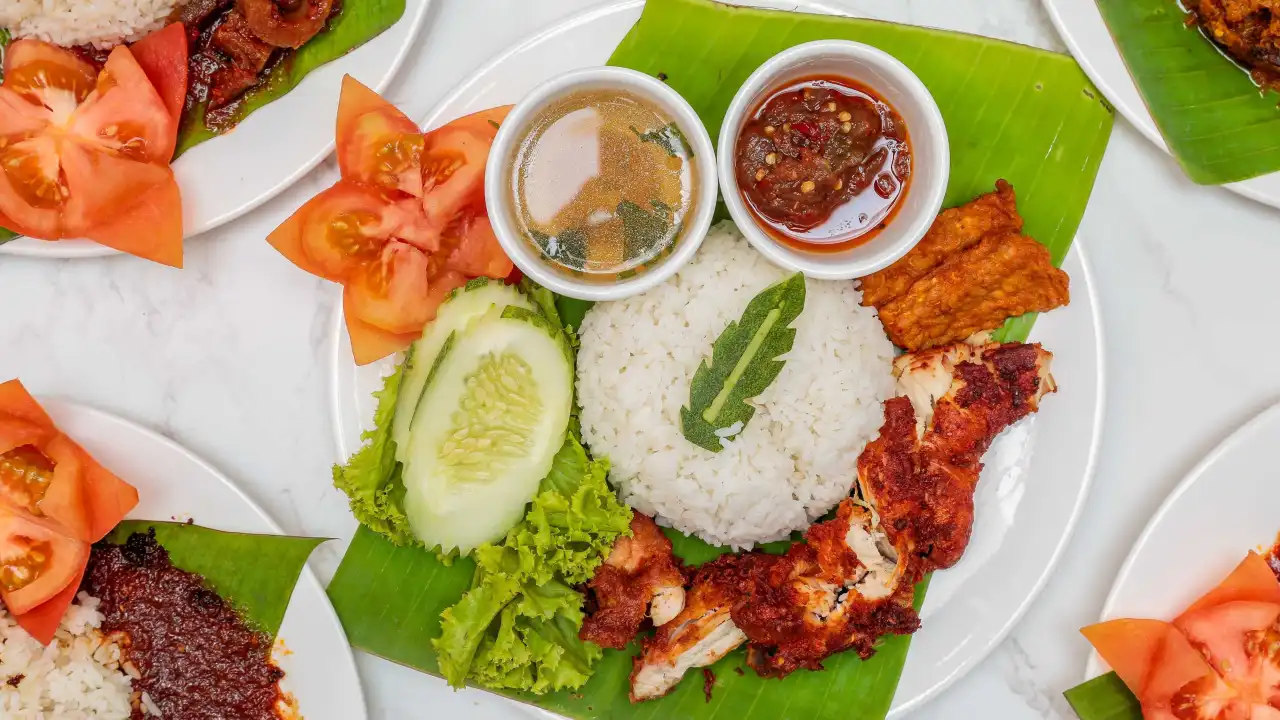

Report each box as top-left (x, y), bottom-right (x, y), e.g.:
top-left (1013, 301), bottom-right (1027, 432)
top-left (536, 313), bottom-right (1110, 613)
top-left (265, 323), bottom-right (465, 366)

top-left (879, 234), bottom-right (1070, 351)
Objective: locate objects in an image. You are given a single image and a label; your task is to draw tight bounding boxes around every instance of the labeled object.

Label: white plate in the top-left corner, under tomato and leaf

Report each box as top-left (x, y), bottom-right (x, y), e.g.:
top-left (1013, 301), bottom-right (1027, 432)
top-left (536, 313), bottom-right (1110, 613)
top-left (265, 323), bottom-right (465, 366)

top-left (0, 0), bottom-right (431, 258)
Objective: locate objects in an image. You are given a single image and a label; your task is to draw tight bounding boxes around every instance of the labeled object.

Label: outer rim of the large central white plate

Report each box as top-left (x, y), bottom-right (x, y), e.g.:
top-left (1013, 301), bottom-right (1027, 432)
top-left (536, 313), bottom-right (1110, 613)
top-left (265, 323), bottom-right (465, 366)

top-left (329, 0), bottom-right (1107, 719)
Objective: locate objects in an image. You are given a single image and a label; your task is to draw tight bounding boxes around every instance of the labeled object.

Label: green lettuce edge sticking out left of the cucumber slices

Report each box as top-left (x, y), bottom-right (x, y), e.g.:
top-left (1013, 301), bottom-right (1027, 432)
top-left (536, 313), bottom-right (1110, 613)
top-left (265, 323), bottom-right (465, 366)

top-left (333, 363), bottom-right (420, 546)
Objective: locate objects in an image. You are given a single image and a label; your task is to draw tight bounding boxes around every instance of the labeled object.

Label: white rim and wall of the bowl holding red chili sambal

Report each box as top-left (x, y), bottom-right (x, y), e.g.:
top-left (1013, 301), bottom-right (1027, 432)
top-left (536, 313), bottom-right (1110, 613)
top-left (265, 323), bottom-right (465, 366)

top-left (717, 40), bottom-right (951, 279)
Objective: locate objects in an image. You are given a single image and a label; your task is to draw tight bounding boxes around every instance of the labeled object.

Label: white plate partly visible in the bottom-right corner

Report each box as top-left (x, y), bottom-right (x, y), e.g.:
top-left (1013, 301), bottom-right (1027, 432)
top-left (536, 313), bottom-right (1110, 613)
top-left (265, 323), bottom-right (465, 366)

top-left (1087, 397), bottom-right (1280, 678)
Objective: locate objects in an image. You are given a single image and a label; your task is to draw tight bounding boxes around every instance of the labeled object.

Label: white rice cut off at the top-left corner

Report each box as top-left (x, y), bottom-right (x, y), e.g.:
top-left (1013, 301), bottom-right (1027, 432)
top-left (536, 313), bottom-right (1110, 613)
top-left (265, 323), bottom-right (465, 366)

top-left (0, 0), bottom-right (179, 49)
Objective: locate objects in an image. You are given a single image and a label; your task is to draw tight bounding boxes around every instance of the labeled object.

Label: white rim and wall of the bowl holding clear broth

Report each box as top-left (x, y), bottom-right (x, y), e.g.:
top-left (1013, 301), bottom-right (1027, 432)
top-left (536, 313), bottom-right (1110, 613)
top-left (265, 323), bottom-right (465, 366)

top-left (484, 67), bottom-right (717, 300)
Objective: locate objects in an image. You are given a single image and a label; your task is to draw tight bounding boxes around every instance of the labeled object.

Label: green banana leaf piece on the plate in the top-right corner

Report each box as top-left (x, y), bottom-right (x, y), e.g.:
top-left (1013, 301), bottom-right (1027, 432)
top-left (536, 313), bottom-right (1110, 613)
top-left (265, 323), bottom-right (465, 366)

top-left (1097, 0), bottom-right (1280, 184)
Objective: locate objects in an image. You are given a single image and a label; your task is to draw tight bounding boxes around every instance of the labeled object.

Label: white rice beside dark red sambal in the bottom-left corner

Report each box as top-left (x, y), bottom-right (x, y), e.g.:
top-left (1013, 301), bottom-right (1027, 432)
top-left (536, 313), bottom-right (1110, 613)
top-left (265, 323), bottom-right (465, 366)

top-left (0, 591), bottom-right (132, 720)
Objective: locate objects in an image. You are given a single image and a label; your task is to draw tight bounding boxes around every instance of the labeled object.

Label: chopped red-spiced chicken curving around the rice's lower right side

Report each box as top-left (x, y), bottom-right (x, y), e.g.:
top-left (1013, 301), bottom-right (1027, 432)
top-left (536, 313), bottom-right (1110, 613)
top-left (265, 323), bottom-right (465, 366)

top-left (584, 343), bottom-right (1057, 702)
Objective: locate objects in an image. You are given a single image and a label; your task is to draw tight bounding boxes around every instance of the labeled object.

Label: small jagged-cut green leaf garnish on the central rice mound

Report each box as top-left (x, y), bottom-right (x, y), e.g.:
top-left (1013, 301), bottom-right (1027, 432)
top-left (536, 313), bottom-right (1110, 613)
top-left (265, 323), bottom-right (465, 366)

top-left (680, 273), bottom-right (805, 452)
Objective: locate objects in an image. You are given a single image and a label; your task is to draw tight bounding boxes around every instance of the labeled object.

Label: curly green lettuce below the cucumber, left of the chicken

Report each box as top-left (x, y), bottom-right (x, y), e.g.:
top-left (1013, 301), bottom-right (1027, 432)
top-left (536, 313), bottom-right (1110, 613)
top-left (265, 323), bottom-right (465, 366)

top-left (433, 436), bottom-right (631, 694)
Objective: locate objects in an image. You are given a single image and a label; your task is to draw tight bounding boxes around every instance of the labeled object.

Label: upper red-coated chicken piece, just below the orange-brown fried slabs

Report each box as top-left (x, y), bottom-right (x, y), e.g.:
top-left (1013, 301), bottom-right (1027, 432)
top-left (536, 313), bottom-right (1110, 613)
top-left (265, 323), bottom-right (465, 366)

top-left (858, 343), bottom-right (1057, 571)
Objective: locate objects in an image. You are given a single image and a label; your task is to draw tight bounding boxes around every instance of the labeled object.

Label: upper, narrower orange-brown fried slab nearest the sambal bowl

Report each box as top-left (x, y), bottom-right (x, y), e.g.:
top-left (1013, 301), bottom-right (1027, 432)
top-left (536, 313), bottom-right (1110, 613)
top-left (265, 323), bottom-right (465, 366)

top-left (863, 179), bottom-right (1023, 307)
